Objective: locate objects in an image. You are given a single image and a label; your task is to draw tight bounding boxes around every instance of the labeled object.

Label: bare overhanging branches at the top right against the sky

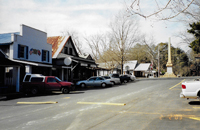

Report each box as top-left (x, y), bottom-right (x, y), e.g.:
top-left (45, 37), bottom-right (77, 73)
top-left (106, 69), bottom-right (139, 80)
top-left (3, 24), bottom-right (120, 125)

top-left (127, 0), bottom-right (200, 20)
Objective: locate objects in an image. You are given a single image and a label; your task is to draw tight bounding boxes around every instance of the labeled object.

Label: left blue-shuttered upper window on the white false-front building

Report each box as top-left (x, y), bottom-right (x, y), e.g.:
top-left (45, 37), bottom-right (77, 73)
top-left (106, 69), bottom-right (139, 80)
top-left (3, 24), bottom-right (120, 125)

top-left (18, 44), bottom-right (28, 59)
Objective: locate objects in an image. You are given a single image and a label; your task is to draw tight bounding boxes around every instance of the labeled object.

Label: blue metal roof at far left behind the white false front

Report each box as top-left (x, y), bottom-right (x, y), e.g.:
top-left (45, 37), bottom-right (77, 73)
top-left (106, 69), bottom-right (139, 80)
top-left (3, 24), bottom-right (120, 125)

top-left (0, 32), bottom-right (20, 45)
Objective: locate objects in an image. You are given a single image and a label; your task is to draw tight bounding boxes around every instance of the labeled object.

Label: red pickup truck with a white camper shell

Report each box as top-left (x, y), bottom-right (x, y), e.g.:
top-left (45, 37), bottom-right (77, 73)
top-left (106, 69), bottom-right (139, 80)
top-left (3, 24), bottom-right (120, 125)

top-left (22, 74), bottom-right (75, 95)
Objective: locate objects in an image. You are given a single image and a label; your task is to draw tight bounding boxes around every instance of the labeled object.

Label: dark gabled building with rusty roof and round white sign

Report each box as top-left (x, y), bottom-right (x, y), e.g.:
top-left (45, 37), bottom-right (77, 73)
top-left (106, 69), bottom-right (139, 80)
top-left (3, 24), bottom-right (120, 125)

top-left (47, 36), bottom-right (97, 82)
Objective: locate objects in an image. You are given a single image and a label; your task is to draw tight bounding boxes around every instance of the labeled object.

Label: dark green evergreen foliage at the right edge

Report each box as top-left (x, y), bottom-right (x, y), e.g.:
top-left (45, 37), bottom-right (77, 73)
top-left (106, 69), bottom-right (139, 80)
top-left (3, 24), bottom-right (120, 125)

top-left (188, 21), bottom-right (200, 54)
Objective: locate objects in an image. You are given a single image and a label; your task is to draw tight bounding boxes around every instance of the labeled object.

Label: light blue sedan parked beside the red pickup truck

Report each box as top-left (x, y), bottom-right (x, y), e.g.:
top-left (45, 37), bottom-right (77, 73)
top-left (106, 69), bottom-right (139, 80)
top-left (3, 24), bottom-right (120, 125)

top-left (76, 76), bottom-right (113, 88)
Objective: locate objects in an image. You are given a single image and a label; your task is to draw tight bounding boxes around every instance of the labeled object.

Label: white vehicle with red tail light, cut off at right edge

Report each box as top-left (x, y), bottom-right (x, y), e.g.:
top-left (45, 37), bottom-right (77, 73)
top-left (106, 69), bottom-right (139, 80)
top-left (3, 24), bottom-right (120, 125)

top-left (180, 79), bottom-right (200, 99)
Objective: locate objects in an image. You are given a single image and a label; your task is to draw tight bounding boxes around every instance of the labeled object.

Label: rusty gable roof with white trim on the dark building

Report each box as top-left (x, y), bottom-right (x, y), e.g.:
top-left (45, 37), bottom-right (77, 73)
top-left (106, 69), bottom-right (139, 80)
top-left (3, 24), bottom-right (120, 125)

top-left (47, 36), bottom-right (78, 58)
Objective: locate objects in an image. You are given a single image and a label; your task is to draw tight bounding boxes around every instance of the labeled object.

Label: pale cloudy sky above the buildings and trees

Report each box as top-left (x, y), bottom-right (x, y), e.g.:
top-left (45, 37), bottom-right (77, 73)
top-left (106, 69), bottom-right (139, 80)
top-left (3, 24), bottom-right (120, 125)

top-left (0, 0), bottom-right (191, 50)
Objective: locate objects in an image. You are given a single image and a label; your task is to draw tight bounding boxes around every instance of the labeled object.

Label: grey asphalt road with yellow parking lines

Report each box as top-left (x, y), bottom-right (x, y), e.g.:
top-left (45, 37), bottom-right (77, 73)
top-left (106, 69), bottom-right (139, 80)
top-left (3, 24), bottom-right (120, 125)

top-left (0, 79), bottom-right (200, 130)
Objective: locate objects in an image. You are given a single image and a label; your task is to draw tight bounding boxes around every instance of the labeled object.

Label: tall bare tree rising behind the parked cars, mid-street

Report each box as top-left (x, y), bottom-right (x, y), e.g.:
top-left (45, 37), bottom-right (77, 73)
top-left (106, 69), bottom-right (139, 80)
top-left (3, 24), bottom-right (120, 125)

top-left (110, 12), bottom-right (139, 73)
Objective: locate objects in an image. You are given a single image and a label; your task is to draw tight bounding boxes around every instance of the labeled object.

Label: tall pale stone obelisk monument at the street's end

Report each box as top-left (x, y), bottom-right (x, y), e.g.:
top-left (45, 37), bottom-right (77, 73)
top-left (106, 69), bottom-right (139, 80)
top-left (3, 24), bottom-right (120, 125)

top-left (163, 38), bottom-right (176, 77)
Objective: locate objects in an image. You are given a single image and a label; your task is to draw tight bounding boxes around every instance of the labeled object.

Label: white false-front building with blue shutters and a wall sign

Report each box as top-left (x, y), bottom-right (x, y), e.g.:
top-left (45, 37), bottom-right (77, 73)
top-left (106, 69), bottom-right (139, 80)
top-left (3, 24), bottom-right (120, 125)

top-left (0, 24), bottom-right (52, 92)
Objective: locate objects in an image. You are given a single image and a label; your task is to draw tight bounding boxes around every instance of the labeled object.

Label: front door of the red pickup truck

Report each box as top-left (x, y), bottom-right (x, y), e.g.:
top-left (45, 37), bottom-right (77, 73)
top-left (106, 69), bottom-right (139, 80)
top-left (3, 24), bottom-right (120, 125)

top-left (46, 77), bottom-right (61, 90)
